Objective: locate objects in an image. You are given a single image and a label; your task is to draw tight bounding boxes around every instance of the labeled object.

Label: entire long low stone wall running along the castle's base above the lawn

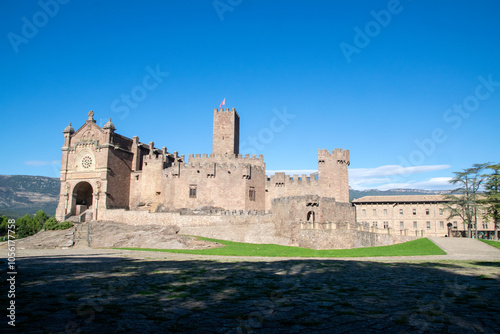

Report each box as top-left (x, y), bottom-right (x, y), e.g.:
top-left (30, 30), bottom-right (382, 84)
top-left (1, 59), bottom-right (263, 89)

top-left (102, 209), bottom-right (417, 249)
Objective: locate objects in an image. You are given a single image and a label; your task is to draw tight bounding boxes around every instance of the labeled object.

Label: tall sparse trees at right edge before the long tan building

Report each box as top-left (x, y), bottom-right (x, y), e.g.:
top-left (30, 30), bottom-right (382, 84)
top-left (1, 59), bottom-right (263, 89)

top-left (445, 163), bottom-right (500, 240)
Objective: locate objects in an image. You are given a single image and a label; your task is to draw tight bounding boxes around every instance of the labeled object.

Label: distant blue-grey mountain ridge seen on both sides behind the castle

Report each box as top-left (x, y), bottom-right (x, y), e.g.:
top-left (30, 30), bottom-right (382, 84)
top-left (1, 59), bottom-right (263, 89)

top-left (0, 175), bottom-right (452, 218)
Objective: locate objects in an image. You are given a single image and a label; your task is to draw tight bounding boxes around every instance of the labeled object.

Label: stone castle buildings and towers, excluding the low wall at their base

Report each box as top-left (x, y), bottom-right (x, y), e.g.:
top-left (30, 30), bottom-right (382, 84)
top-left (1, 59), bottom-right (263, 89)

top-left (57, 108), bottom-right (349, 220)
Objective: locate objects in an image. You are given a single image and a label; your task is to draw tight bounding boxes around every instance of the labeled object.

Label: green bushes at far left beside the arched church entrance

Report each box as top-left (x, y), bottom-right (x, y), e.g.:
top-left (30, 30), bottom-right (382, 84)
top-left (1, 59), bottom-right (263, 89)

top-left (0, 210), bottom-right (73, 240)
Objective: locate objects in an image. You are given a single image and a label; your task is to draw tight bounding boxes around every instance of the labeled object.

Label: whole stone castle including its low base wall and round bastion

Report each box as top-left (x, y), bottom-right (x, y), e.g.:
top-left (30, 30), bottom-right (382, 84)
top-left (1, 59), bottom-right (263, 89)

top-left (56, 108), bottom-right (418, 248)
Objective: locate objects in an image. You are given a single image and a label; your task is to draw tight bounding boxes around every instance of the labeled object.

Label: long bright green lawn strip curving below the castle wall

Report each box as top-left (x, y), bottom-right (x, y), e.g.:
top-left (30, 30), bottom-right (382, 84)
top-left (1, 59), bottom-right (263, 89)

top-left (117, 237), bottom-right (446, 257)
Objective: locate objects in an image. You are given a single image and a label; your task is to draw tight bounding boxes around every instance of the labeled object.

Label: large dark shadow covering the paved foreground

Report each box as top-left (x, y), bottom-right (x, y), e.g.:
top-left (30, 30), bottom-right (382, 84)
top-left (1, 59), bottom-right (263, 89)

top-left (2, 254), bottom-right (500, 333)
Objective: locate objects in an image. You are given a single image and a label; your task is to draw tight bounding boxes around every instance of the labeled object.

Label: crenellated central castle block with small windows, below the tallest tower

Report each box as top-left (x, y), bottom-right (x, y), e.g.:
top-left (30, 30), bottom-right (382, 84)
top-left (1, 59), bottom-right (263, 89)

top-left (130, 154), bottom-right (265, 210)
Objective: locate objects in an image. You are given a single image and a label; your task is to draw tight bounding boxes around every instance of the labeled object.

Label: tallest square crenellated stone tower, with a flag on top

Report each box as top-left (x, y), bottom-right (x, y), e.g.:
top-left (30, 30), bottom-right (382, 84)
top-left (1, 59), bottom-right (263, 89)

top-left (212, 108), bottom-right (240, 155)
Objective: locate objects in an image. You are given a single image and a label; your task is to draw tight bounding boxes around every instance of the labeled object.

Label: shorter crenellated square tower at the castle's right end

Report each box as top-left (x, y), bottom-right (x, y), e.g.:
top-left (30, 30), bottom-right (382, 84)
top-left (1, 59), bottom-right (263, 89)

top-left (318, 149), bottom-right (351, 203)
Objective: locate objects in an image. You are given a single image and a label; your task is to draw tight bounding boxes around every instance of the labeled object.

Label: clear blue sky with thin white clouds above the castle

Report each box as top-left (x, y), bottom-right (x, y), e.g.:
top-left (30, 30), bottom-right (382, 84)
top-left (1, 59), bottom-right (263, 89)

top-left (0, 0), bottom-right (500, 189)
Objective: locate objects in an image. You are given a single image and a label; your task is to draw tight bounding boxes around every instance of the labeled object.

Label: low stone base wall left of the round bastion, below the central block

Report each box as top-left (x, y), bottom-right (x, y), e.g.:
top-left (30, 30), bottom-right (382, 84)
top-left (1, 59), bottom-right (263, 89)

top-left (102, 209), bottom-right (290, 245)
